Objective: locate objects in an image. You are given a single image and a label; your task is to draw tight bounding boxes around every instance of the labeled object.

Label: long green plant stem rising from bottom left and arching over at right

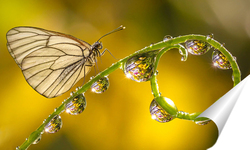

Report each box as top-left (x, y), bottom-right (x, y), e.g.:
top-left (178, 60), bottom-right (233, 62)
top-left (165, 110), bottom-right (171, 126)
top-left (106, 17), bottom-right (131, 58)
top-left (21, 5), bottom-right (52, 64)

top-left (18, 35), bottom-right (241, 150)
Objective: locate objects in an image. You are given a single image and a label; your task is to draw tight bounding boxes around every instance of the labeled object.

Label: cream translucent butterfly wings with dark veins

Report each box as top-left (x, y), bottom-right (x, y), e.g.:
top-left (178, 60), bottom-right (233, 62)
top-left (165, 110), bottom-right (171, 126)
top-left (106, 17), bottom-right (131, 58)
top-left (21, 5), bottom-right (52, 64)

top-left (7, 27), bottom-right (94, 98)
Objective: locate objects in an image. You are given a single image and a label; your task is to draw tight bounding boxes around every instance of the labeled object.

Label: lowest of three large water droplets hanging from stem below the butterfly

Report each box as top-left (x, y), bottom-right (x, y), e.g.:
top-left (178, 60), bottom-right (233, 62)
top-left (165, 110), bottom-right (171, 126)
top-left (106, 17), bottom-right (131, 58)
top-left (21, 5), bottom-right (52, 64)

top-left (44, 115), bottom-right (62, 133)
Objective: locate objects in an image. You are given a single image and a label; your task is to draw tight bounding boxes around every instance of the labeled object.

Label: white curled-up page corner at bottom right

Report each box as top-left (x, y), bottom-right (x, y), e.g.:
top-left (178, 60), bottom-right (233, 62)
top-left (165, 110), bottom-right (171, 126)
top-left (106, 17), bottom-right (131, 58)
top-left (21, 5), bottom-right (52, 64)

top-left (197, 75), bottom-right (250, 150)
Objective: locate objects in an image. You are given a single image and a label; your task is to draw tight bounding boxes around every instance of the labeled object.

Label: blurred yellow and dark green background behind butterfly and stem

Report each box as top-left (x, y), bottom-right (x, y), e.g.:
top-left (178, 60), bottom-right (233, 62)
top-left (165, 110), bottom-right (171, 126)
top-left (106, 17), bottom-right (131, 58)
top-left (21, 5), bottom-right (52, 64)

top-left (0, 0), bottom-right (250, 150)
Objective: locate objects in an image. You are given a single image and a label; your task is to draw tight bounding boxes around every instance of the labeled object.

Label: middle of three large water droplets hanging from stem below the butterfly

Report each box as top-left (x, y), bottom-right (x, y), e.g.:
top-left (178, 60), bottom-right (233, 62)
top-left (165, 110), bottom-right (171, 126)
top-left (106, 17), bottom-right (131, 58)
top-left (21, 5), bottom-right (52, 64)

top-left (65, 94), bottom-right (87, 115)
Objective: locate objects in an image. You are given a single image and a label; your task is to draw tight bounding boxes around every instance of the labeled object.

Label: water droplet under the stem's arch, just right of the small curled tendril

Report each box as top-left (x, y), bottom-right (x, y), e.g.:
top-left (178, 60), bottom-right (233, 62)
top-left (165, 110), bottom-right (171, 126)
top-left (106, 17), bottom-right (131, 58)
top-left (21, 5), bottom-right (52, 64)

top-left (185, 40), bottom-right (211, 55)
